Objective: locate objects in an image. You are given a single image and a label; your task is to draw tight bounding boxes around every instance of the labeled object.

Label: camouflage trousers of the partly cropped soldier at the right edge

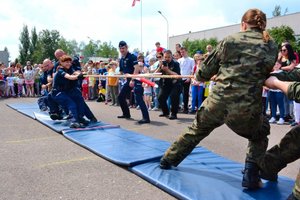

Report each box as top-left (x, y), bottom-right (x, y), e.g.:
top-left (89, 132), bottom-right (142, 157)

top-left (257, 126), bottom-right (300, 199)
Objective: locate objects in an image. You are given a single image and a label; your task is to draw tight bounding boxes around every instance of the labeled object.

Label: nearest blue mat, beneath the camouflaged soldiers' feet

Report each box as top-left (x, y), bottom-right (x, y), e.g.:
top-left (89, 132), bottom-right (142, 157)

top-left (130, 147), bottom-right (294, 200)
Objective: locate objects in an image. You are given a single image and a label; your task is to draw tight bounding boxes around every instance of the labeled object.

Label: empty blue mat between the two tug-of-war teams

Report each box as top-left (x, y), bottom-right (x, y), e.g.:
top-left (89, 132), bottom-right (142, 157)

top-left (63, 128), bottom-right (170, 166)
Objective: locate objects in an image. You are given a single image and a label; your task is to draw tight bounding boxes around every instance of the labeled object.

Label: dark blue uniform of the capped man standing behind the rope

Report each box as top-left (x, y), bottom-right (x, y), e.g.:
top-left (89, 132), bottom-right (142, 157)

top-left (118, 52), bottom-right (137, 118)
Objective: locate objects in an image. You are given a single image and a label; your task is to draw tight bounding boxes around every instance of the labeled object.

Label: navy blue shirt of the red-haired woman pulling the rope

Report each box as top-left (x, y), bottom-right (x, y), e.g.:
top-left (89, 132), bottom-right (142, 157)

top-left (53, 68), bottom-right (76, 91)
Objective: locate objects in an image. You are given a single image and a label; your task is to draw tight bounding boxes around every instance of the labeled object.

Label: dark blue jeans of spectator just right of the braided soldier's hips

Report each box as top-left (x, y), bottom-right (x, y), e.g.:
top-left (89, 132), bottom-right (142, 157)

top-left (269, 91), bottom-right (284, 118)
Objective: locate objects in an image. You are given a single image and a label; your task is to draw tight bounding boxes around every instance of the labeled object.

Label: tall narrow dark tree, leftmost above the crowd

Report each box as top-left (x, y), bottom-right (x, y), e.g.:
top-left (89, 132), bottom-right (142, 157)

top-left (19, 25), bottom-right (30, 64)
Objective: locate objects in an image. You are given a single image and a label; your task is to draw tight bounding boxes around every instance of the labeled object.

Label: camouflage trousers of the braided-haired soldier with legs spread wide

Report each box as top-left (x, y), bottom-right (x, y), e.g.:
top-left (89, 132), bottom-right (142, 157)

top-left (163, 97), bottom-right (270, 166)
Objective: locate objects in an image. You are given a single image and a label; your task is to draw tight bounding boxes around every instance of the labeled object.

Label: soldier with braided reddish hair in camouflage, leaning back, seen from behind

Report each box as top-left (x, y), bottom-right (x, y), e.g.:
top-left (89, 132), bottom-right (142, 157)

top-left (160, 9), bottom-right (278, 189)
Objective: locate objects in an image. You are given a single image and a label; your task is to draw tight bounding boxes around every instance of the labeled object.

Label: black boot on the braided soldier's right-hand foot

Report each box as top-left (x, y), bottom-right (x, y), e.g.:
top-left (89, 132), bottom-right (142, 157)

top-left (242, 161), bottom-right (262, 189)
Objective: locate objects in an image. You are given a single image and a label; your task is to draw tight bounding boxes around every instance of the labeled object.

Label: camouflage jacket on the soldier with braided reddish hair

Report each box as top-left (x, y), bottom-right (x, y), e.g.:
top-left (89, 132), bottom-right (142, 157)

top-left (196, 29), bottom-right (278, 106)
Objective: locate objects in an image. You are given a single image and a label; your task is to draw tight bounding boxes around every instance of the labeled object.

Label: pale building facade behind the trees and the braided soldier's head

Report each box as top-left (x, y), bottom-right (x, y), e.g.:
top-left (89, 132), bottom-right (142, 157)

top-left (169, 12), bottom-right (300, 51)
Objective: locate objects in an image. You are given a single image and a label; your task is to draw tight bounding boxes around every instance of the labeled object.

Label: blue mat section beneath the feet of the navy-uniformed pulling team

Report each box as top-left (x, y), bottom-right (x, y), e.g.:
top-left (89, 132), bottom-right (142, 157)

top-left (34, 112), bottom-right (112, 133)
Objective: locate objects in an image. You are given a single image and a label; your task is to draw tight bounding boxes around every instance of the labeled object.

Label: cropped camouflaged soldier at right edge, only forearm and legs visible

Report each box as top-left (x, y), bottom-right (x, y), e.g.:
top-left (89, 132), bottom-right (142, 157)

top-left (257, 74), bottom-right (300, 200)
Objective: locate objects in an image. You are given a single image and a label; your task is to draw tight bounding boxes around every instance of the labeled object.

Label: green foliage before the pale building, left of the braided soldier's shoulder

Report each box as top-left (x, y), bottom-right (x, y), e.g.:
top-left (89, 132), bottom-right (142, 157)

top-left (182, 38), bottom-right (218, 57)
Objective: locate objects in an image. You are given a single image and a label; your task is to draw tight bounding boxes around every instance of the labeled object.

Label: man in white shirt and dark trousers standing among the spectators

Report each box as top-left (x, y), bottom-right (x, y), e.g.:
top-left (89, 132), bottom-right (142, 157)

top-left (178, 47), bottom-right (195, 113)
